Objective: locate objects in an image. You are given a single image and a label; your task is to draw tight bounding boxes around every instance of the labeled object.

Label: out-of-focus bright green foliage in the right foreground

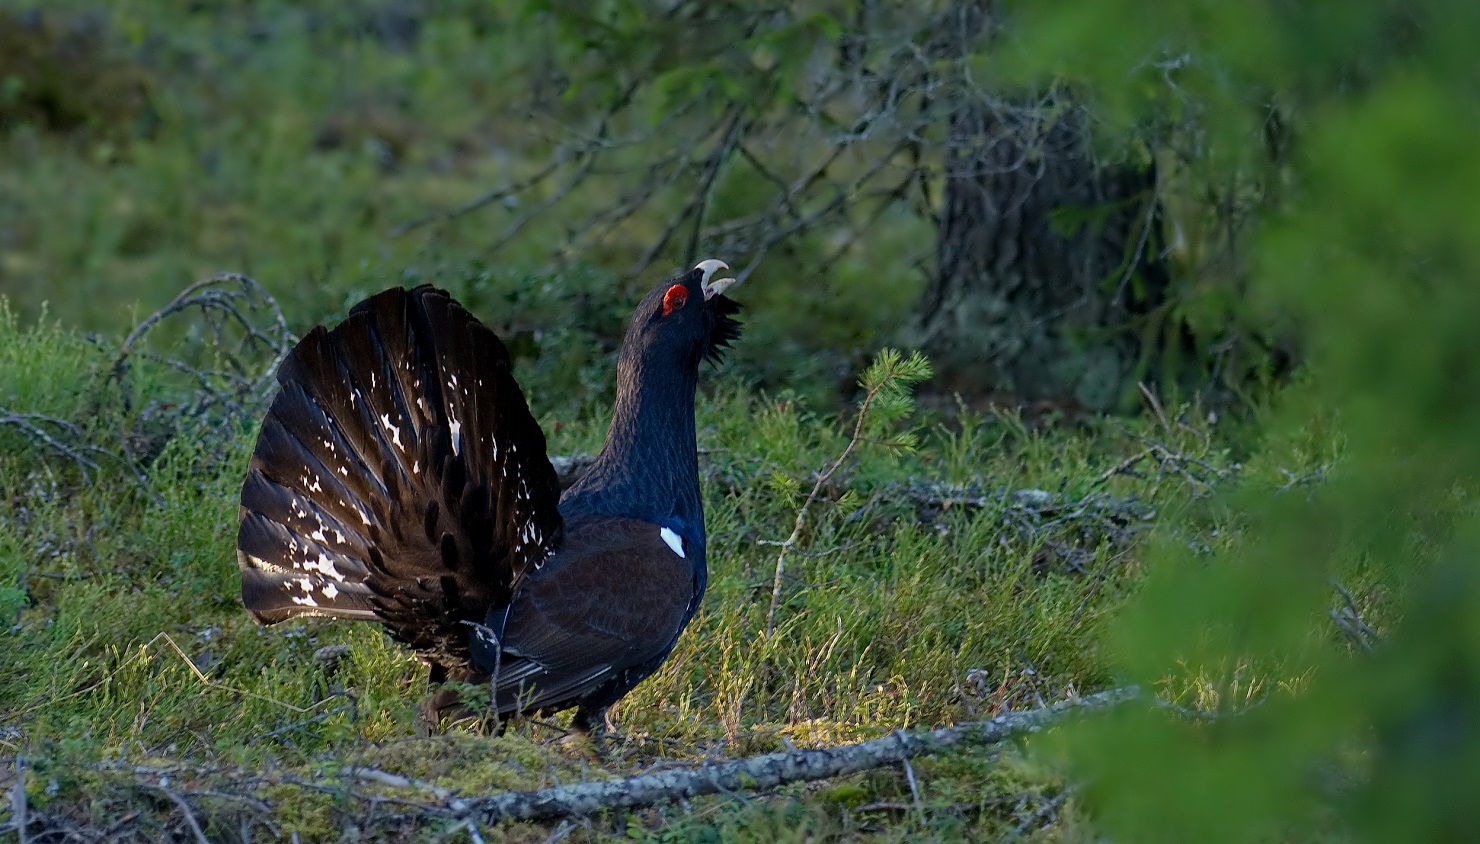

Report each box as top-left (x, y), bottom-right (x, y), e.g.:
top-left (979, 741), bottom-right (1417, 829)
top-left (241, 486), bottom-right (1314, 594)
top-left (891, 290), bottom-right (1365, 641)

top-left (1000, 0), bottom-right (1480, 841)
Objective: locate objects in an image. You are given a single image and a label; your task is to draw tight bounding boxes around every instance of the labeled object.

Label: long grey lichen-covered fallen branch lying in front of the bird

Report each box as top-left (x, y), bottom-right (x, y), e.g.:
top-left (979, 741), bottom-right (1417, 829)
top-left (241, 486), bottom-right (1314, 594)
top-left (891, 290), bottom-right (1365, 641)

top-left (450, 687), bottom-right (1141, 823)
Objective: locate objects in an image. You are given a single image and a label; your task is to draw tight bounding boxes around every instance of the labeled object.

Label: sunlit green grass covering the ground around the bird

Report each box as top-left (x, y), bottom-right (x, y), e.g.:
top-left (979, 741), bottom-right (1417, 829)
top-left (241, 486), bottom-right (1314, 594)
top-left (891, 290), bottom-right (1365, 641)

top-left (0, 294), bottom-right (1332, 841)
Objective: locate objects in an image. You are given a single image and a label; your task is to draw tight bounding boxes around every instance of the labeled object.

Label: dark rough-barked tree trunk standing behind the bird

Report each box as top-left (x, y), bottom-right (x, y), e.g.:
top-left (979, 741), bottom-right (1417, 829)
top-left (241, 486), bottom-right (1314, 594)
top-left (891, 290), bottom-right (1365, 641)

top-left (907, 102), bottom-right (1168, 412)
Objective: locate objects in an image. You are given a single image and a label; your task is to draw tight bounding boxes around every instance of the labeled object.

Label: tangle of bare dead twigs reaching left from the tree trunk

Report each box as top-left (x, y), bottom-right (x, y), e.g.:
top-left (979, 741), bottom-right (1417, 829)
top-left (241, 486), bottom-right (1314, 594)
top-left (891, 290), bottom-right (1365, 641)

top-left (372, 3), bottom-right (1030, 287)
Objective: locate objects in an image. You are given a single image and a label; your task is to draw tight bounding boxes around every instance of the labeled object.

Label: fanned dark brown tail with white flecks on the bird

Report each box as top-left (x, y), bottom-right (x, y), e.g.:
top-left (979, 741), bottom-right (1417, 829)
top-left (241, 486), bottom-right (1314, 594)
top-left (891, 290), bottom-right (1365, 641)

top-left (237, 287), bottom-right (559, 644)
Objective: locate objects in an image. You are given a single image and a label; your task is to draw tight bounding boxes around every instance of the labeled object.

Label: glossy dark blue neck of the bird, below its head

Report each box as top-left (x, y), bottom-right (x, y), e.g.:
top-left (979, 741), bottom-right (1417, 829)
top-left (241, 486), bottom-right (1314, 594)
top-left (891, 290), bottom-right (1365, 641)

top-left (561, 357), bottom-right (704, 533)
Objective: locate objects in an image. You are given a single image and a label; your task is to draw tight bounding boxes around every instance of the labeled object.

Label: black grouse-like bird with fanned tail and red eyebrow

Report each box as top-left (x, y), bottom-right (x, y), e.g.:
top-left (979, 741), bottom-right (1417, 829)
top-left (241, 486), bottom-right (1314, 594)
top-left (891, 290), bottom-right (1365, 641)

top-left (237, 259), bottom-right (740, 733)
